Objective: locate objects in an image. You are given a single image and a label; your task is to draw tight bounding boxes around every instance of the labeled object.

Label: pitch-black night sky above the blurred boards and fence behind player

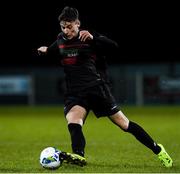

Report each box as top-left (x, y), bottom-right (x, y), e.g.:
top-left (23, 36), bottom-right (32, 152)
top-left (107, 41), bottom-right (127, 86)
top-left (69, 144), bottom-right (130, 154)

top-left (0, 0), bottom-right (180, 67)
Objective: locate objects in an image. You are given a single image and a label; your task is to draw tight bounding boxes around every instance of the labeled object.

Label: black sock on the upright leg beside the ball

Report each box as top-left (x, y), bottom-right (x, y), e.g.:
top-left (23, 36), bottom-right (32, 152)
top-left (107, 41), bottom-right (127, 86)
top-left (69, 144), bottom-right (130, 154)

top-left (68, 123), bottom-right (86, 156)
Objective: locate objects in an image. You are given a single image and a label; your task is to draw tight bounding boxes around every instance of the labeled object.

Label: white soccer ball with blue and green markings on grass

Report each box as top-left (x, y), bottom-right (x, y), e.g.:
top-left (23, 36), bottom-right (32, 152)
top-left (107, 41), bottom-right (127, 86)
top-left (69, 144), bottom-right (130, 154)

top-left (40, 147), bottom-right (62, 170)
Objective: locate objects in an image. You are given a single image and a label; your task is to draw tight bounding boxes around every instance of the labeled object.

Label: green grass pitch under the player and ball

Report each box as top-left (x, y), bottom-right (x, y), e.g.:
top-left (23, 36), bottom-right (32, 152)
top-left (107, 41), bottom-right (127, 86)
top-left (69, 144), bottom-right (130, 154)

top-left (0, 106), bottom-right (180, 173)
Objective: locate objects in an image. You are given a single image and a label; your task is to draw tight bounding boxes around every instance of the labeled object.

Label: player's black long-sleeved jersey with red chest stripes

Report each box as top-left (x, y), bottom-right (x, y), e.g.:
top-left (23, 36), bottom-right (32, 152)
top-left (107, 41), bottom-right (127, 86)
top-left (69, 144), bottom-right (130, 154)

top-left (48, 32), bottom-right (117, 91)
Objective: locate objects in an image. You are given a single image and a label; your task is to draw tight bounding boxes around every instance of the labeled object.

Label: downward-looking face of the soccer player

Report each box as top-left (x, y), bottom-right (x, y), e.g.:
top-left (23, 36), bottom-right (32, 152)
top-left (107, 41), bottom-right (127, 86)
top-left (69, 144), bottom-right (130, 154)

top-left (60, 21), bottom-right (80, 39)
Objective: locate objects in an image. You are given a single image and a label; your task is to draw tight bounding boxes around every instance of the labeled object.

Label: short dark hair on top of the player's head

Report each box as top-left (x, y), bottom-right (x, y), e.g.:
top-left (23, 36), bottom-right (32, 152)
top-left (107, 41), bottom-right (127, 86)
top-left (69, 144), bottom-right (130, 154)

top-left (58, 6), bottom-right (79, 22)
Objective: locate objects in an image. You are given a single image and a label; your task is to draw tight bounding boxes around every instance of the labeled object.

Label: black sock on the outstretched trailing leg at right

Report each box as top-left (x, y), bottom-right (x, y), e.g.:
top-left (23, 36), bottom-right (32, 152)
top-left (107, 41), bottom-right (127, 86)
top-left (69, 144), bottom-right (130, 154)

top-left (126, 121), bottom-right (161, 154)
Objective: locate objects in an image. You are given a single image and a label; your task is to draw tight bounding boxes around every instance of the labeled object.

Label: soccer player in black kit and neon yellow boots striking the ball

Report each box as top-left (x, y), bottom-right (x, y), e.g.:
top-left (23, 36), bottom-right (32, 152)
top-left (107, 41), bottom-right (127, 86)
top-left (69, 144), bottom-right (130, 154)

top-left (37, 7), bottom-right (173, 167)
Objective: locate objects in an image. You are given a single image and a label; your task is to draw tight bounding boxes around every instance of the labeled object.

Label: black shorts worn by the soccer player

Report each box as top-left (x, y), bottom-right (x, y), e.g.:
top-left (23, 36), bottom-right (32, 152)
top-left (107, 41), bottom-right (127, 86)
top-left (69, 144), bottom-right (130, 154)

top-left (64, 84), bottom-right (119, 117)
